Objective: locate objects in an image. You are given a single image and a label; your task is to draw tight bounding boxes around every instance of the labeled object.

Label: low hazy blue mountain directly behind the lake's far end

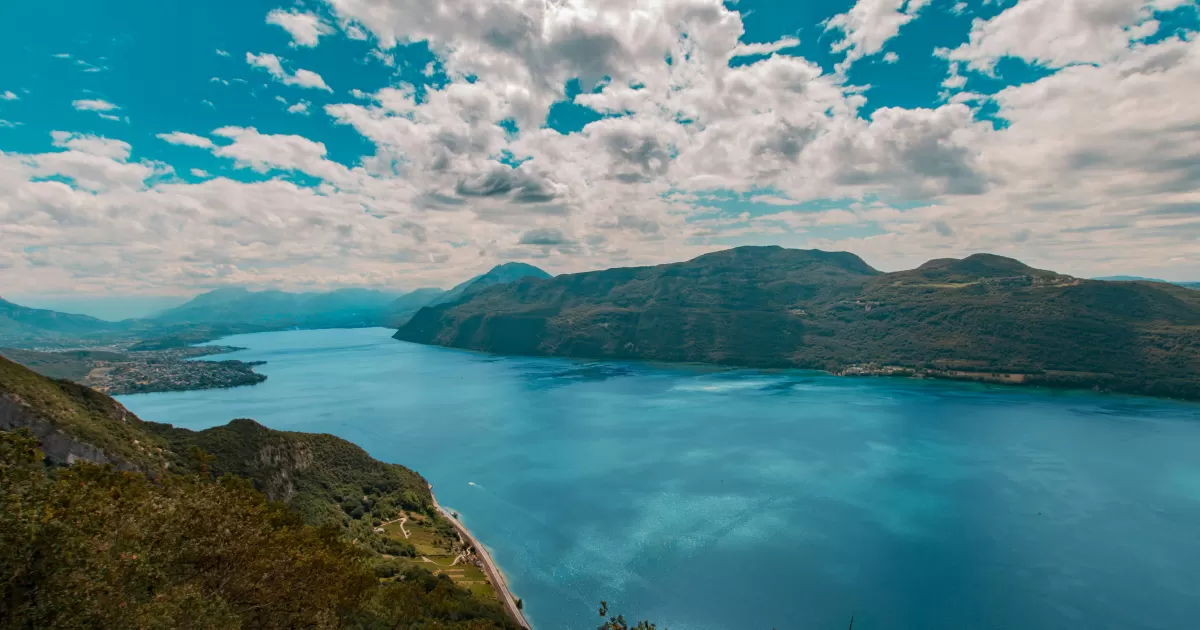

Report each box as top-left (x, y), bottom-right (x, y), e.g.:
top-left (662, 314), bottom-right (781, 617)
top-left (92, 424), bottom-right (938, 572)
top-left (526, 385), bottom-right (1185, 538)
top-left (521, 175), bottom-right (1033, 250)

top-left (151, 288), bottom-right (397, 330)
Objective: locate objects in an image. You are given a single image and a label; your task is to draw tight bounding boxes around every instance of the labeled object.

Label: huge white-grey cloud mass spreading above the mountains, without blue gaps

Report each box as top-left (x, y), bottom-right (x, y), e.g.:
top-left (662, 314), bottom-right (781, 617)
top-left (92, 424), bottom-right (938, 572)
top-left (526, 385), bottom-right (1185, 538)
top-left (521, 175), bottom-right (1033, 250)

top-left (0, 0), bottom-right (1200, 290)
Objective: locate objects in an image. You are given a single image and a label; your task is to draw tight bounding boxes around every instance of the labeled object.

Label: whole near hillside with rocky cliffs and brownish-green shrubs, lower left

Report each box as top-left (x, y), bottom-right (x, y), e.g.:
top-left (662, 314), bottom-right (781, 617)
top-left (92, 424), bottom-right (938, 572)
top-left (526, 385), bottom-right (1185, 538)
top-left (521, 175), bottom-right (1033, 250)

top-left (0, 359), bottom-right (516, 630)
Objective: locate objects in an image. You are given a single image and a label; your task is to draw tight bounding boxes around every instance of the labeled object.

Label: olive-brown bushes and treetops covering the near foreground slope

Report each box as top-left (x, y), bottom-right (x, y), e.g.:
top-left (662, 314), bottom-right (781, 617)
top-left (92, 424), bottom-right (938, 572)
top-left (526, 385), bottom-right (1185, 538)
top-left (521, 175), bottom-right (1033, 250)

top-left (0, 432), bottom-right (511, 629)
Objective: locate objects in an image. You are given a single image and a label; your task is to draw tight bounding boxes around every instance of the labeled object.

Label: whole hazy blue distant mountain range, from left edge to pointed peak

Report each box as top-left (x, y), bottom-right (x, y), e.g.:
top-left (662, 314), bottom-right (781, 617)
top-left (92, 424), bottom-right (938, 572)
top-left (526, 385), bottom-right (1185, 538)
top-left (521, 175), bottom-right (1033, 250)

top-left (0, 263), bottom-right (550, 350)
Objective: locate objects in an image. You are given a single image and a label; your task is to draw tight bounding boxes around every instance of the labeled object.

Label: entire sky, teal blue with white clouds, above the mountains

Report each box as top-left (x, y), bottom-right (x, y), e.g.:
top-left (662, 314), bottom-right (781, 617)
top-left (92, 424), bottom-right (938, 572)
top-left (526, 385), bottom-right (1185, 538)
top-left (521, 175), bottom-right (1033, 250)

top-left (0, 0), bottom-right (1200, 304)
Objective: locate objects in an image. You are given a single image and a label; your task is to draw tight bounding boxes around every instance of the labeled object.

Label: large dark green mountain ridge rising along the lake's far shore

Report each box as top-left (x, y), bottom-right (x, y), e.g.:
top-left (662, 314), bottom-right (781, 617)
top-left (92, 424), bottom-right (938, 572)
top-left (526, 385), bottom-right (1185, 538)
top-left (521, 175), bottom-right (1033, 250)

top-left (395, 247), bottom-right (1200, 397)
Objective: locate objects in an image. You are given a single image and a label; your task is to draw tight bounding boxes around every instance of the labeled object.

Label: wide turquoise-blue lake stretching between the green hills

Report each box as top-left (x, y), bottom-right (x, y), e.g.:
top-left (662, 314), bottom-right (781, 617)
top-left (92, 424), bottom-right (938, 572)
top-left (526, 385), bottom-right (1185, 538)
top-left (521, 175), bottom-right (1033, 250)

top-left (120, 329), bottom-right (1200, 630)
